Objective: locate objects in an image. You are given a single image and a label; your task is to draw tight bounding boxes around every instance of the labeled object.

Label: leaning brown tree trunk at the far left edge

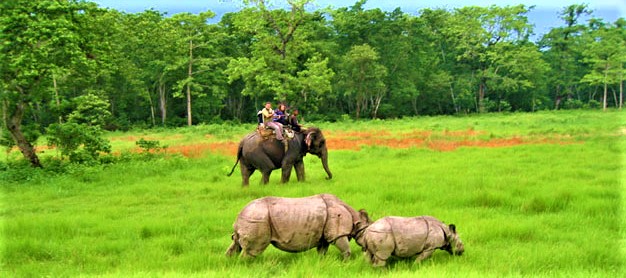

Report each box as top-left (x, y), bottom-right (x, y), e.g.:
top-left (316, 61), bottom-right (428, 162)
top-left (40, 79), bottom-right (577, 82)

top-left (3, 97), bottom-right (43, 168)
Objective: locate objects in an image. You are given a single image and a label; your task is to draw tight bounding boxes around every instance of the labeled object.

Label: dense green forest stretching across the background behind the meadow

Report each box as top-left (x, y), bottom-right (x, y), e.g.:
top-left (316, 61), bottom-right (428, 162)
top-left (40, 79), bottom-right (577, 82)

top-left (0, 0), bottom-right (626, 166)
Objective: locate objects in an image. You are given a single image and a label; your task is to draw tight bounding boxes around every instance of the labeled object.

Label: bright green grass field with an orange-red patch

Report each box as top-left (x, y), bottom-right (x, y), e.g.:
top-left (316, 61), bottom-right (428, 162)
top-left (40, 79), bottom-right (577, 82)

top-left (0, 111), bottom-right (626, 277)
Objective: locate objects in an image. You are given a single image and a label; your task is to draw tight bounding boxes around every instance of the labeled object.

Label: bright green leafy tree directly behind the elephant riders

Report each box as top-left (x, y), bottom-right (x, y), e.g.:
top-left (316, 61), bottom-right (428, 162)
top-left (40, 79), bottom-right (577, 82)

top-left (226, 0), bottom-right (333, 113)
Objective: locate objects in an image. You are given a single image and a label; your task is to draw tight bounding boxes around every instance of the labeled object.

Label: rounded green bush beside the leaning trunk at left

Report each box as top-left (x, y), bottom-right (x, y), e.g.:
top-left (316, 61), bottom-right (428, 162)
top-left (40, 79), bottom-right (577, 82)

top-left (46, 122), bottom-right (111, 163)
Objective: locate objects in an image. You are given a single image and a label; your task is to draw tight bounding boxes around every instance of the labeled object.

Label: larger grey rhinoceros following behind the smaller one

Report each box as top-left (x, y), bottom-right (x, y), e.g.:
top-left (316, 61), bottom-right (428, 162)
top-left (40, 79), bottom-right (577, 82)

top-left (226, 194), bottom-right (370, 259)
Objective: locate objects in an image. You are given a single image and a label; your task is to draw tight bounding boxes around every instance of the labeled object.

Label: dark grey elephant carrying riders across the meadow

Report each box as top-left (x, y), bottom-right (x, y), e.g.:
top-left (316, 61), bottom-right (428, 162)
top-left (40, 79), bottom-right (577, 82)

top-left (228, 127), bottom-right (333, 186)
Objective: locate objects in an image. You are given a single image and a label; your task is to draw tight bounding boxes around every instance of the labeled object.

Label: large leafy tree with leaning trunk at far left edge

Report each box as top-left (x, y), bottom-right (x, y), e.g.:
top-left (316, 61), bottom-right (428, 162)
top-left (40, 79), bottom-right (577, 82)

top-left (0, 0), bottom-right (95, 167)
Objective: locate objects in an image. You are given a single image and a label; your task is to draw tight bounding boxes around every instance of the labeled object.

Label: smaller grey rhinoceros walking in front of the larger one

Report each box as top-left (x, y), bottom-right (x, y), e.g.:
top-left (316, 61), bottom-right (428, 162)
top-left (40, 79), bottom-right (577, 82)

top-left (357, 216), bottom-right (464, 266)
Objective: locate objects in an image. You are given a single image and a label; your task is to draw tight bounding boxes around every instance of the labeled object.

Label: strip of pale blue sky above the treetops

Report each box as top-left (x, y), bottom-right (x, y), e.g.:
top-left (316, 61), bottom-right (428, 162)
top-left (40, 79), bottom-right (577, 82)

top-left (91, 0), bottom-right (626, 40)
